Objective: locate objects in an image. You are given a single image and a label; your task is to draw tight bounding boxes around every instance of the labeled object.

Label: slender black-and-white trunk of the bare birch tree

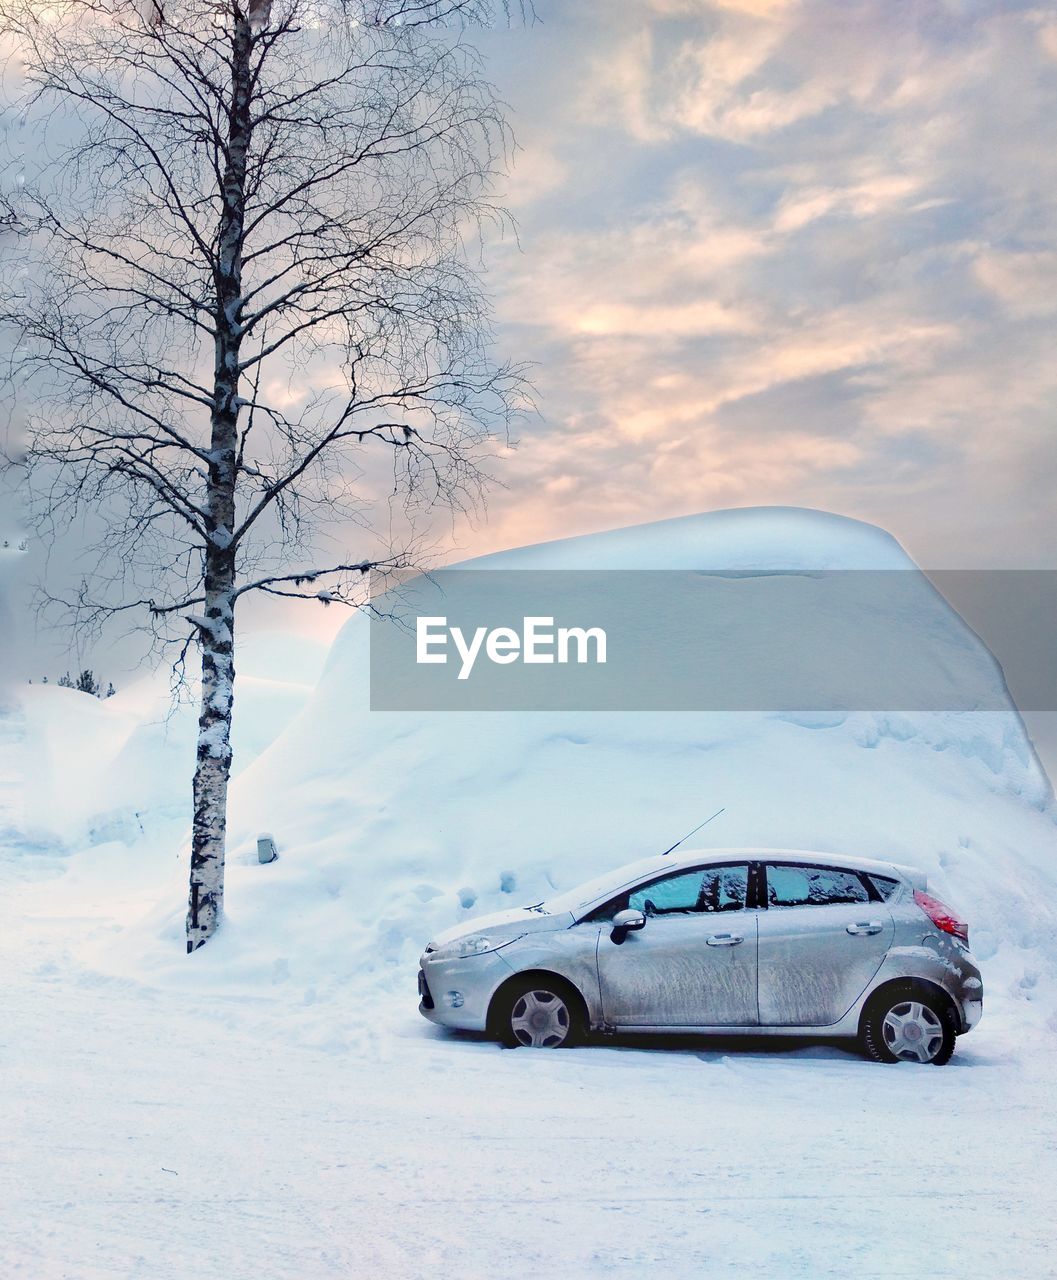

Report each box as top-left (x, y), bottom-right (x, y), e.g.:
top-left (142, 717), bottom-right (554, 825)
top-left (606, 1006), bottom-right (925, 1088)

top-left (187, 10), bottom-right (252, 952)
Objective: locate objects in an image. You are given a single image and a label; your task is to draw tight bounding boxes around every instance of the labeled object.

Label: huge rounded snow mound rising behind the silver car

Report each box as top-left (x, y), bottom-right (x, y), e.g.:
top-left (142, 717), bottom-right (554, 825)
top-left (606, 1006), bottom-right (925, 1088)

top-left (92, 509), bottom-right (1057, 1029)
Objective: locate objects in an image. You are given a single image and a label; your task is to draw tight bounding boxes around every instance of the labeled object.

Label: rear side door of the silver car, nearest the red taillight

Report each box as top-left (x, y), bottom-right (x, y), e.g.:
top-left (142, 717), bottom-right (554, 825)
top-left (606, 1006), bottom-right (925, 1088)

top-left (759, 863), bottom-right (894, 1027)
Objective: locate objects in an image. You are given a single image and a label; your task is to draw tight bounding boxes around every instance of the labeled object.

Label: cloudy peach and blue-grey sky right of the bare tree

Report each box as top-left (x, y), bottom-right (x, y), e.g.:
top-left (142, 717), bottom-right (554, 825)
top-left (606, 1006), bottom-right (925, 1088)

top-left (4, 0), bottom-right (1057, 680)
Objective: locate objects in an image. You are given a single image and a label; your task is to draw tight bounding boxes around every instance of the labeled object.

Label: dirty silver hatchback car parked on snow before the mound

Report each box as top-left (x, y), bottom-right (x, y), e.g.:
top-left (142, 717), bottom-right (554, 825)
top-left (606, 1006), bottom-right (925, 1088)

top-left (418, 849), bottom-right (983, 1065)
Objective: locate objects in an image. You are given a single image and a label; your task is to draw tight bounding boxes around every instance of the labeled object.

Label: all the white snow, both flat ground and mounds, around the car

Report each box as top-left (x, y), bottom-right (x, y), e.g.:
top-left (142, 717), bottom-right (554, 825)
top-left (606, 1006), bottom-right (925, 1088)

top-left (0, 512), bottom-right (1057, 1280)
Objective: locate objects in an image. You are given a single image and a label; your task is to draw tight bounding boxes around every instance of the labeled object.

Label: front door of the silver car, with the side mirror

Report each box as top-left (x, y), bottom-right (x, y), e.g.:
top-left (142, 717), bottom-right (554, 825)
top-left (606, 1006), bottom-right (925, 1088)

top-left (595, 863), bottom-right (758, 1027)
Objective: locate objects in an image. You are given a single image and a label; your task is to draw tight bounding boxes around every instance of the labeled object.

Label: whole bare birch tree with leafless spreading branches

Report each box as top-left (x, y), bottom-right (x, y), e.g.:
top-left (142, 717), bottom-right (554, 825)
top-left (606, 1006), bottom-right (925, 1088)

top-left (0, 0), bottom-right (522, 951)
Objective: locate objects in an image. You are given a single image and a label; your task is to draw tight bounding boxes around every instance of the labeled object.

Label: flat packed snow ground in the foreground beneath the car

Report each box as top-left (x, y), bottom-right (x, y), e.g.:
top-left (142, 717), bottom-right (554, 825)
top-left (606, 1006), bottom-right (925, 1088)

top-left (0, 900), bottom-right (1057, 1280)
